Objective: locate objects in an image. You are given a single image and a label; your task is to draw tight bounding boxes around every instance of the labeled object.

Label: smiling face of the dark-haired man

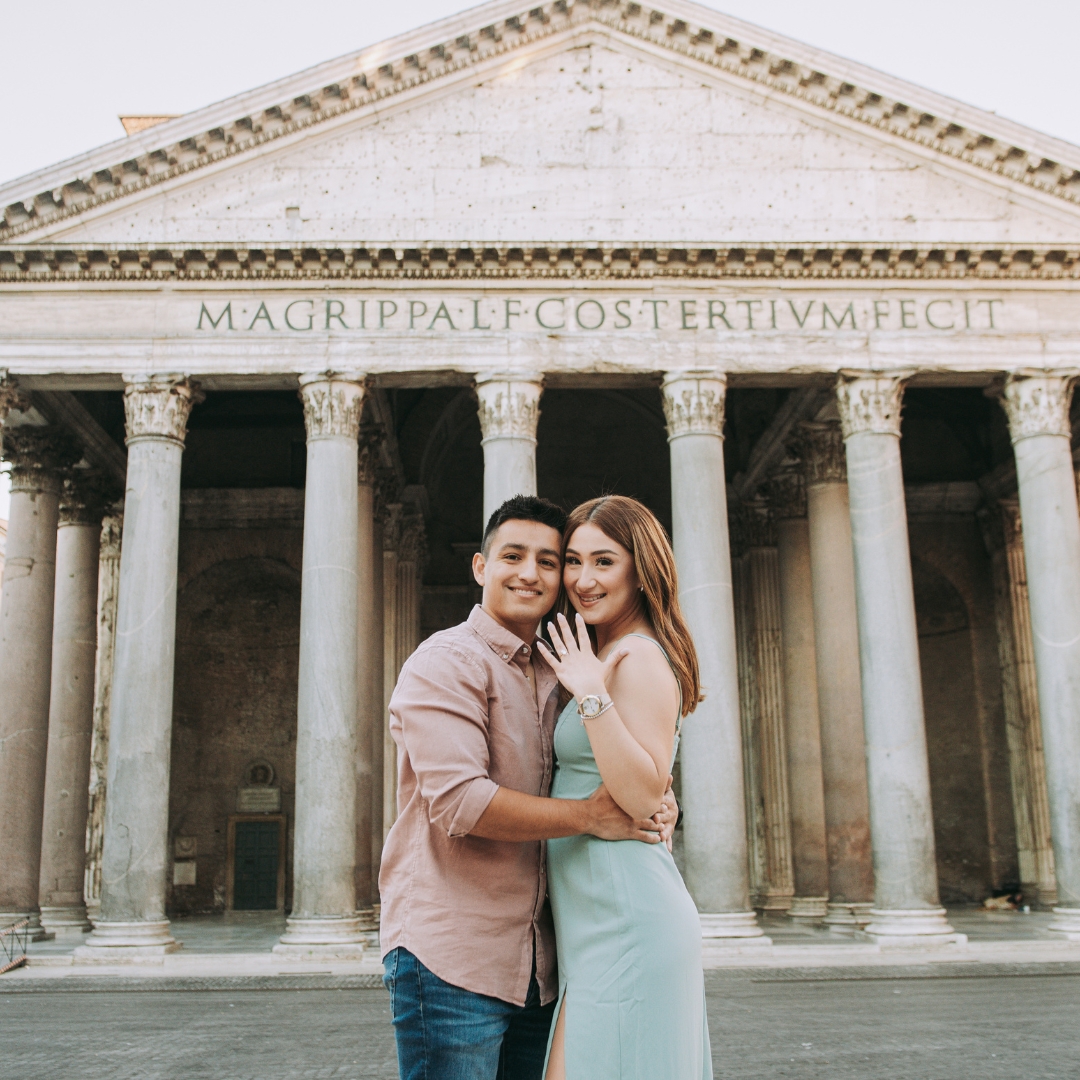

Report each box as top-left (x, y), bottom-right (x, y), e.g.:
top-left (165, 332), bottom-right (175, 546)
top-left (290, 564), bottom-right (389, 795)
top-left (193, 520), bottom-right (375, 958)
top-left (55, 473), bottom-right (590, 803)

top-left (473, 521), bottom-right (563, 636)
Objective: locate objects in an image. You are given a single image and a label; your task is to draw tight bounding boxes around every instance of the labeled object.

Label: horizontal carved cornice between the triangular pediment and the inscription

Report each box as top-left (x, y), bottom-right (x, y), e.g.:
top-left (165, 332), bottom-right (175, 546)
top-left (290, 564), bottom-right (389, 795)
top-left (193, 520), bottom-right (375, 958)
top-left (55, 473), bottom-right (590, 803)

top-left (0, 238), bottom-right (1080, 285)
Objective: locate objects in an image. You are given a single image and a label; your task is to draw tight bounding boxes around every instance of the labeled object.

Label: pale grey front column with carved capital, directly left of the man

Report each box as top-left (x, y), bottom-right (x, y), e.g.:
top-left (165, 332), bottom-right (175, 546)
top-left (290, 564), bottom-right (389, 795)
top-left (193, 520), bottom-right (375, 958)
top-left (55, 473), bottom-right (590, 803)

top-left (274, 373), bottom-right (364, 959)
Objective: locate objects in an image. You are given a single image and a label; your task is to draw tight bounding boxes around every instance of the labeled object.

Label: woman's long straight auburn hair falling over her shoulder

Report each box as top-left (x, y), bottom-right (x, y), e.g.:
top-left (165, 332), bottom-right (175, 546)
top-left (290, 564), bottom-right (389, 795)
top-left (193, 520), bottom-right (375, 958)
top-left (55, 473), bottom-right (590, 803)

top-left (559, 495), bottom-right (702, 716)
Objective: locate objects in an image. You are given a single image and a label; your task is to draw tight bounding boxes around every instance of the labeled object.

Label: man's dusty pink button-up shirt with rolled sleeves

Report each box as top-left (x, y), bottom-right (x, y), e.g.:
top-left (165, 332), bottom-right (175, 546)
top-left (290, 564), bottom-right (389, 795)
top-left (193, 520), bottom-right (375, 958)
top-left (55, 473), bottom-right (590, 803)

top-left (379, 607), bottom-right (558, 1005)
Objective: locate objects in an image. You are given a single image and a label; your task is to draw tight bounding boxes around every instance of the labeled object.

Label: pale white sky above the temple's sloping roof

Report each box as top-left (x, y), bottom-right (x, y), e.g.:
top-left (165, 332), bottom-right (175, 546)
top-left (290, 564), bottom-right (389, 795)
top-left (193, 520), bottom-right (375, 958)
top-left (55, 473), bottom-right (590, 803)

top-left (0, 0), bottom-right (1080, 518)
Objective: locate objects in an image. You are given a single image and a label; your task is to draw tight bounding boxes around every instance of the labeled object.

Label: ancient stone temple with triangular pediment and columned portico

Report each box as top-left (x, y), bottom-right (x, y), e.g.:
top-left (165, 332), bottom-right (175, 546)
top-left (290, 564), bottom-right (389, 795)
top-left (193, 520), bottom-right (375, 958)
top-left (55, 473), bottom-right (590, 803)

top-left (0, 0), bottom-right (1080, 960)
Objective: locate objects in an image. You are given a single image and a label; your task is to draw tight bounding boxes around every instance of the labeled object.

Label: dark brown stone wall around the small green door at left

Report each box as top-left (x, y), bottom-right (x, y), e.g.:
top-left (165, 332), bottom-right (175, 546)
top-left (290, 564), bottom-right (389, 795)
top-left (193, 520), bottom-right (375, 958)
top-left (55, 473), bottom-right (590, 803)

top-left (170, 528), bottom-right (302, 914)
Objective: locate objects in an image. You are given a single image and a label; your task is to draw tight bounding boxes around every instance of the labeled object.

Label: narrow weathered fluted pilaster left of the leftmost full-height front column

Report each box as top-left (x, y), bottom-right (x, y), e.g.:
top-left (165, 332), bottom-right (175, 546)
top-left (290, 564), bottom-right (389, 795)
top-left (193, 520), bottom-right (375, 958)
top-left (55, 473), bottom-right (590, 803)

top-left (83, 514), bottom-right (124, 921)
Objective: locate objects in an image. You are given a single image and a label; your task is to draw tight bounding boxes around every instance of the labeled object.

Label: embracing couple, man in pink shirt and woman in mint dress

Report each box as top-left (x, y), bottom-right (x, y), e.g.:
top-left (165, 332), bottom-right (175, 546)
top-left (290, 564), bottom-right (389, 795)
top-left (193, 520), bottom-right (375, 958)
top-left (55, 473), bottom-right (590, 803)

top-left (379, 496), bottom-right (713, 1080)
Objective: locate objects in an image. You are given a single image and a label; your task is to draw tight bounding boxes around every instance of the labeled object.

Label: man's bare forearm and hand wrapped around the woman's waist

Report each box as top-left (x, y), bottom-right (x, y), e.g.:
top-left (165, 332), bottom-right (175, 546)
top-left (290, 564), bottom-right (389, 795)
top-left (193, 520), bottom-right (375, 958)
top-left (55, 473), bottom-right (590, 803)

top-left (469, 785), bottom-right (660, 843)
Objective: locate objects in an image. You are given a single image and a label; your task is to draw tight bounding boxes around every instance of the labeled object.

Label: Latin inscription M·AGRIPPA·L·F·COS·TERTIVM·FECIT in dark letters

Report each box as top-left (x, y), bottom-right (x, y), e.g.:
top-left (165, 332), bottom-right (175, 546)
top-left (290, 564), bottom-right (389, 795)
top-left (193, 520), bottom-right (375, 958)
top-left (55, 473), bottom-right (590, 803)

top-left (195, 295), bottom-right (1004, 335)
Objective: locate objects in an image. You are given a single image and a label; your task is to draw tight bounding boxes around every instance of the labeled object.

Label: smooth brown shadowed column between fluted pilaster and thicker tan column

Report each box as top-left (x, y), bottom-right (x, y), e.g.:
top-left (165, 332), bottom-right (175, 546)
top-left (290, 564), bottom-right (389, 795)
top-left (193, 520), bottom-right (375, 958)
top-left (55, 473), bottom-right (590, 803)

top-left (770, 468), bottom-right (828, 922)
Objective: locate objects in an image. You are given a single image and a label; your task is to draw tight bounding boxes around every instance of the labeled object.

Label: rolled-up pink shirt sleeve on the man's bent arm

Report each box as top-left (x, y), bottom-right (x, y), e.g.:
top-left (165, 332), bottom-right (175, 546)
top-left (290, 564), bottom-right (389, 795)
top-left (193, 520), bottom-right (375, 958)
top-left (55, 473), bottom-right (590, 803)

top-left (390, 647), bottom-right (499, 836)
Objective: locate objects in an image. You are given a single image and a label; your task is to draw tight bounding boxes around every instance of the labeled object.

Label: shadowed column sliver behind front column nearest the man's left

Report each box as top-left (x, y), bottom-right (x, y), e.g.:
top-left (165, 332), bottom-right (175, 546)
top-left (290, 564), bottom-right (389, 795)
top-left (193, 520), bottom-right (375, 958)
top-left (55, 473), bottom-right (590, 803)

top-left (355, 431), bottom-right (382, 930)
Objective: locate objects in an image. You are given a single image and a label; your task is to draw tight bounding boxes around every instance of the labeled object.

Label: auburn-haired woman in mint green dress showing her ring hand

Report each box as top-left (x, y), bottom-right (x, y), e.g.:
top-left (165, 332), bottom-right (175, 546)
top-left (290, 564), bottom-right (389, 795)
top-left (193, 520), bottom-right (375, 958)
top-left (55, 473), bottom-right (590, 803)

top-left (538, 496), bottom-right (713, 1080)
